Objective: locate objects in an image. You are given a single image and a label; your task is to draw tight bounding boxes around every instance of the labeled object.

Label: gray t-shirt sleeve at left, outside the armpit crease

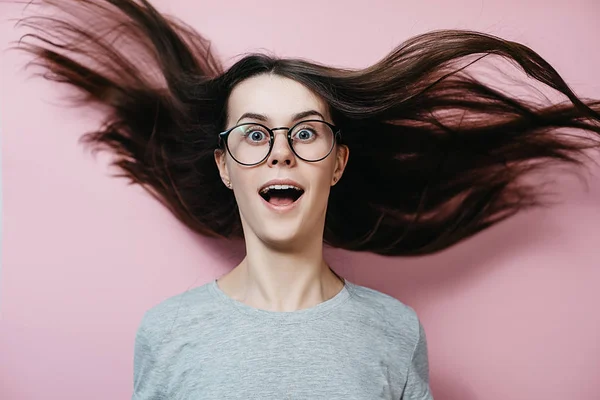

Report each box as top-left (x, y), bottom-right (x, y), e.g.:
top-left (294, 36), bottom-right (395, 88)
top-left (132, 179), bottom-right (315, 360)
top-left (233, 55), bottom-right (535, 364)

top-left (131, 314), bottom-right (165, 400)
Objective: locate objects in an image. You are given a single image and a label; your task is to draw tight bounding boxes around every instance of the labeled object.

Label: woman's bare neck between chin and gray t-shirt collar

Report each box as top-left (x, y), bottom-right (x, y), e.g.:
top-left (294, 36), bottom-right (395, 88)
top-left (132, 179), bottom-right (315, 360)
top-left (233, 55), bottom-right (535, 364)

top-left (218, 228), bottom-right (343, 311)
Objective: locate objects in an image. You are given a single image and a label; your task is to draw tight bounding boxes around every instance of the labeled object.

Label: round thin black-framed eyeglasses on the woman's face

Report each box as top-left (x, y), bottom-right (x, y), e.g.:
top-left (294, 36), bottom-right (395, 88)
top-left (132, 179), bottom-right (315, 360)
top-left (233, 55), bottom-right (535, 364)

top-left (219, 119), bottom-right (341, 166)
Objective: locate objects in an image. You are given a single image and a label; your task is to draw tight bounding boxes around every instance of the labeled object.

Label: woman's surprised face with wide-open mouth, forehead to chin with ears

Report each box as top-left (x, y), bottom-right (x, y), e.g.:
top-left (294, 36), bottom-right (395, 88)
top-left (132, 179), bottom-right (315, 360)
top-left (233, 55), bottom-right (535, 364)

top-left (215, 74), bottom-right (348, 248)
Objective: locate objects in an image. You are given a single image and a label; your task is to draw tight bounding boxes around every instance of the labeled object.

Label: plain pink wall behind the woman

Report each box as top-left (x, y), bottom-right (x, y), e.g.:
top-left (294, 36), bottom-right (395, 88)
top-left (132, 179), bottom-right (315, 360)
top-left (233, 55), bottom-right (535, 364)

top-left (0, 0), bottom-right (600, 400)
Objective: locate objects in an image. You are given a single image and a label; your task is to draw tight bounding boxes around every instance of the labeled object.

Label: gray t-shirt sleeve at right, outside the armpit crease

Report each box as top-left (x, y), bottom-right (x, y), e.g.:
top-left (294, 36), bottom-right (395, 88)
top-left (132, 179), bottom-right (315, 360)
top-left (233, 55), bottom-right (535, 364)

top-left (401, 321), bottom-right (433, 400)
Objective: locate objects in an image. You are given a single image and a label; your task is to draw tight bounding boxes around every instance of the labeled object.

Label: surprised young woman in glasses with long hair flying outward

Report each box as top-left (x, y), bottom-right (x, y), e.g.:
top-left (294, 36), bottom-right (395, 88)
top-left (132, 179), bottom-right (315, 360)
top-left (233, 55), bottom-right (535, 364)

top-left (14, 0), bottom-right (600, 400)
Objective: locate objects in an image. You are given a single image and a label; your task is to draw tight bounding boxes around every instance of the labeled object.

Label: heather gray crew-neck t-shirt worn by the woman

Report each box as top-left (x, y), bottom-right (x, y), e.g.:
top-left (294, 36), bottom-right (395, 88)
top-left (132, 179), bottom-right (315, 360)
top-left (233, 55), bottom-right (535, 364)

top-left (132, 280), bottom-right (432, 400)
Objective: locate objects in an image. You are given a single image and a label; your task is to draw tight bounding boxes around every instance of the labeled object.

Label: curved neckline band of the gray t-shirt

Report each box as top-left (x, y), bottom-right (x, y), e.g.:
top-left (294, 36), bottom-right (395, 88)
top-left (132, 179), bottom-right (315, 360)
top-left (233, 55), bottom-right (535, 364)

top-left (209, 278), bottom-right (354, 323)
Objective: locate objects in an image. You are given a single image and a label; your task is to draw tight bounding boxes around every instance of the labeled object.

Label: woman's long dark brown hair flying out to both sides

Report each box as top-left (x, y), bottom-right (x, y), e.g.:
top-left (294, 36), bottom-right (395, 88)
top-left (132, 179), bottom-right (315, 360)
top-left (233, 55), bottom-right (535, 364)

top-left (12, 0), bottom-right (600, 255)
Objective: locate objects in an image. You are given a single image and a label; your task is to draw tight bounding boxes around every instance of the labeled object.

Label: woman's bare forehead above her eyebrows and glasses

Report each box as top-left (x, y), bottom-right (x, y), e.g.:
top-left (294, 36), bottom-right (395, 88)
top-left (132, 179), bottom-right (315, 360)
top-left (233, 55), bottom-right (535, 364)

top-left (227, 74), bottom-right (330, 123)
